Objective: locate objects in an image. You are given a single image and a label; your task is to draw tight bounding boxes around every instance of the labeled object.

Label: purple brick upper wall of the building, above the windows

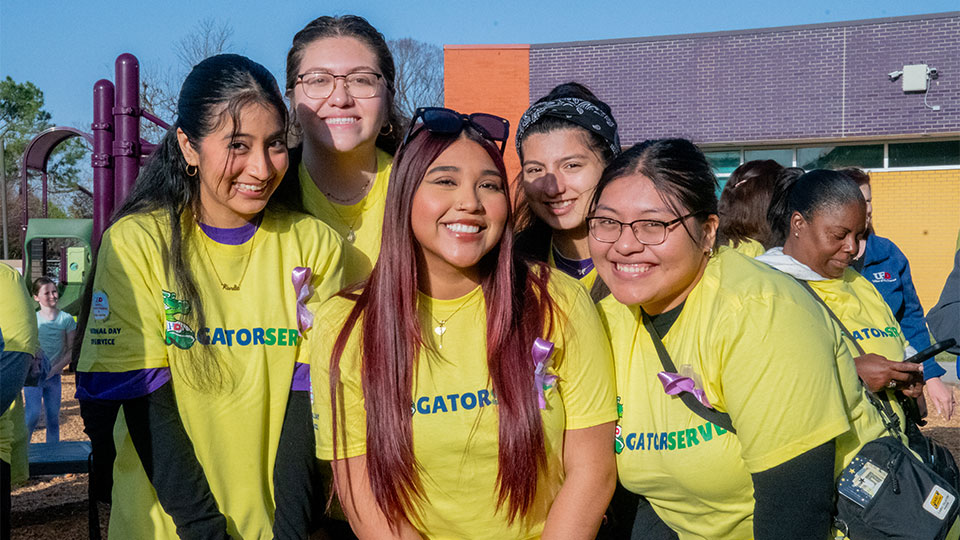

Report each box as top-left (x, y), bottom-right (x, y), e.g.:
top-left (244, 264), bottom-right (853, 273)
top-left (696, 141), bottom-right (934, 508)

top-left (530, 12), bottom-right (960, 144)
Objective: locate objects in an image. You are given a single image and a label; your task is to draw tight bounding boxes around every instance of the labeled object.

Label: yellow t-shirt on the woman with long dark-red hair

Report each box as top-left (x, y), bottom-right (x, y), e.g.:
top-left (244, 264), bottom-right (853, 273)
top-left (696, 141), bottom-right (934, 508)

top-left (307, 272), bottom-right (617, 539)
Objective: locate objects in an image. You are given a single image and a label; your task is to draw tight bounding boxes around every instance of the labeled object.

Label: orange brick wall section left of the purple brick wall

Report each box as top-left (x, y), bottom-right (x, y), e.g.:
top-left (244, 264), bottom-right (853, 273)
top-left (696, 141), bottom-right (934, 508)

top-left (443, 45), bottom-right (530, 175)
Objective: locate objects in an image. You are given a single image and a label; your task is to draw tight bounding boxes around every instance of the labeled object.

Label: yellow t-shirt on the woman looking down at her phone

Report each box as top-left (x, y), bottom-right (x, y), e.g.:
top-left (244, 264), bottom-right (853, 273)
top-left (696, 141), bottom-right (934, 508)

top-left (808, 268), bottom-right (909, 426)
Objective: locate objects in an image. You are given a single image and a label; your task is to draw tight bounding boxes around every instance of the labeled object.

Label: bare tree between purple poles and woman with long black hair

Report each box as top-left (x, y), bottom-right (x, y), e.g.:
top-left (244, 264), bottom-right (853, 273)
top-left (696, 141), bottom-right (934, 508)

top-left (140, 19), bottom-right (233, 141)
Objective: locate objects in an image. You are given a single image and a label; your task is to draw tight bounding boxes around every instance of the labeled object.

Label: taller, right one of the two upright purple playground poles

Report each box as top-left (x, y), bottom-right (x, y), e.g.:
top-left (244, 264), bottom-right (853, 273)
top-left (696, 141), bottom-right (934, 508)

top-left (113, 53), bottom-right (140, 206)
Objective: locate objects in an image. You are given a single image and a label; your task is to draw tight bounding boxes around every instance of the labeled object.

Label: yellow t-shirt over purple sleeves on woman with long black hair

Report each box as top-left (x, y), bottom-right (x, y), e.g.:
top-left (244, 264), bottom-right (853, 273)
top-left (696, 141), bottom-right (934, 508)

top-left (78, 210), bottom-right (342, 539)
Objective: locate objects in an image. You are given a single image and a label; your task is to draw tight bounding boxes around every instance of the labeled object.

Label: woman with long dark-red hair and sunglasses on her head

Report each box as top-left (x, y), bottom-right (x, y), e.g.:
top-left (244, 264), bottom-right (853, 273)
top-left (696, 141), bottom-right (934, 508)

top-left (310, 108), bottom-right (616, 539)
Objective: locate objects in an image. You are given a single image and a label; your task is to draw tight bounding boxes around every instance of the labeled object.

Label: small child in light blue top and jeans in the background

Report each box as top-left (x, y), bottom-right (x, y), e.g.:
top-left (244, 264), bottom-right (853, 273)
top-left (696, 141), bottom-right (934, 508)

top-left (23, 277), bottom-right (77, 443)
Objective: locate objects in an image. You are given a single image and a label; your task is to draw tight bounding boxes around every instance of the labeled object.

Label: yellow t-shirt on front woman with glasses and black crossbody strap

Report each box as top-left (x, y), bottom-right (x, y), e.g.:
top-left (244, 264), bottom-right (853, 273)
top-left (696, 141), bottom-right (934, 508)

top-left (598, 249), bottom-right (883, 540)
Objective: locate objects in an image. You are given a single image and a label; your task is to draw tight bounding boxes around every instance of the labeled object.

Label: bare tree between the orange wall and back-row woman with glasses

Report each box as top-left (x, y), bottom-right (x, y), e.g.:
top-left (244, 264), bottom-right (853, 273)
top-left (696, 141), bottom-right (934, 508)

top-left (387, 38), bottom-right (443, 118)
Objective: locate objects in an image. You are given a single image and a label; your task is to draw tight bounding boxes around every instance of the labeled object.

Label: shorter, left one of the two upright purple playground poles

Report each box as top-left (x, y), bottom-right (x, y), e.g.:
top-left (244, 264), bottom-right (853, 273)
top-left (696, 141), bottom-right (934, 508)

top-left (90, 79), bottom-right (114, 254)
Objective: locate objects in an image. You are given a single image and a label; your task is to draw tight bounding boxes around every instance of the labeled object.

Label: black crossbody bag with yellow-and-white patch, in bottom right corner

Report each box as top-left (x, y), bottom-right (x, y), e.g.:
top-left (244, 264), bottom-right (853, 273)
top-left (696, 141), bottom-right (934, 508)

top-left (834, 437), bottom-right (960, 540)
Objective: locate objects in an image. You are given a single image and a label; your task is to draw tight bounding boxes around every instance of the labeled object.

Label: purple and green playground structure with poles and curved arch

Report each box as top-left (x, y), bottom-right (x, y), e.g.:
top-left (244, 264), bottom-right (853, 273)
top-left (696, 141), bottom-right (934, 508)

top-left (20, 53), bottom-right (170, 315)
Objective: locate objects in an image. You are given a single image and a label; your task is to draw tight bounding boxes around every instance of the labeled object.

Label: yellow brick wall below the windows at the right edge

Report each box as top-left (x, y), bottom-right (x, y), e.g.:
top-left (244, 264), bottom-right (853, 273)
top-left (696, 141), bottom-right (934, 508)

top-left (870, 169), bottom-right (960, 311)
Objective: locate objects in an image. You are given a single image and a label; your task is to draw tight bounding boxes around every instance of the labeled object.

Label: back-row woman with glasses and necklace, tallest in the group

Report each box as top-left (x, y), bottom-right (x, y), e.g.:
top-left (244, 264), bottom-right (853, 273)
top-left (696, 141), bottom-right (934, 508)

top-left (287, 15), bottom-right (403, 281)
